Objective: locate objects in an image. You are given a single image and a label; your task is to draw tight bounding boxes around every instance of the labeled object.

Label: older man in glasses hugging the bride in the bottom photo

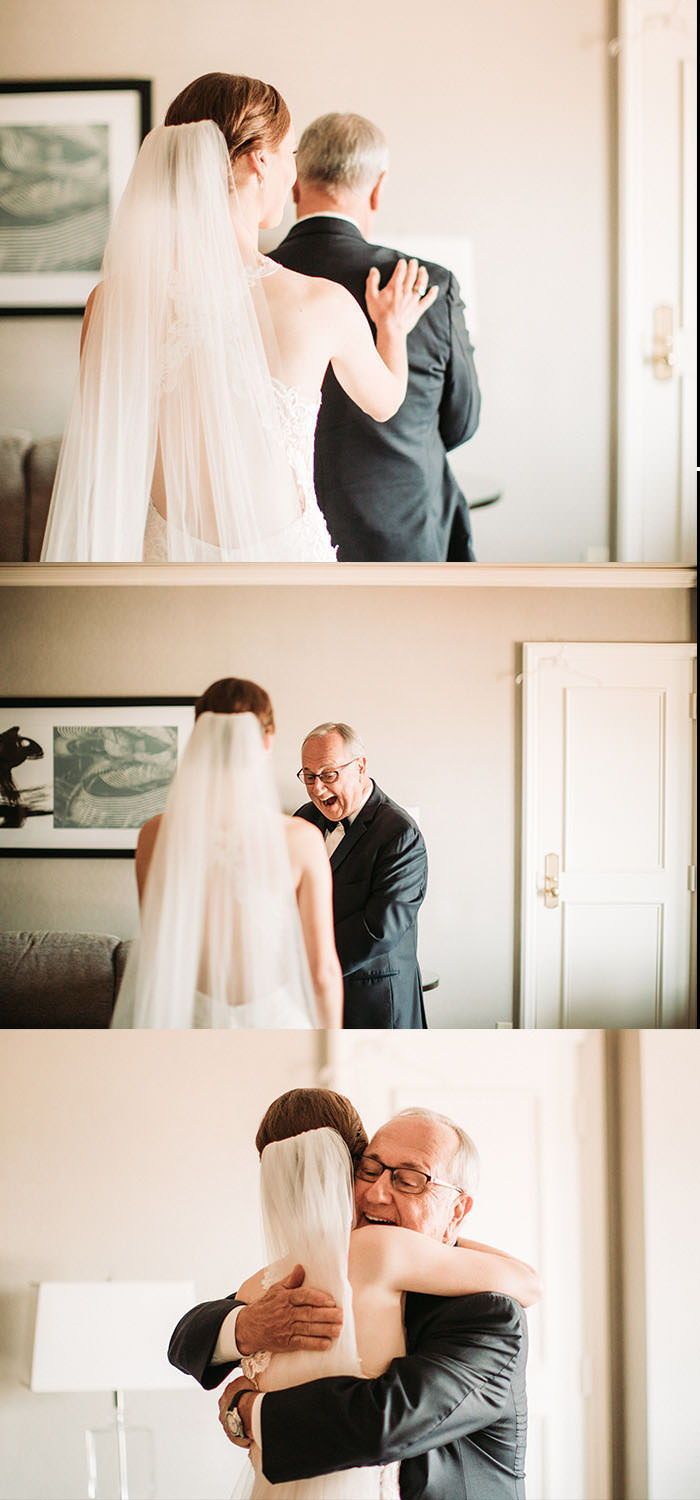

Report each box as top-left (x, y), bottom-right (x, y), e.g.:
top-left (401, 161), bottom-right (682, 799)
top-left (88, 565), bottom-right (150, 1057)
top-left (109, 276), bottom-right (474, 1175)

top-left (169, 1110), bottom-right (527, 1500)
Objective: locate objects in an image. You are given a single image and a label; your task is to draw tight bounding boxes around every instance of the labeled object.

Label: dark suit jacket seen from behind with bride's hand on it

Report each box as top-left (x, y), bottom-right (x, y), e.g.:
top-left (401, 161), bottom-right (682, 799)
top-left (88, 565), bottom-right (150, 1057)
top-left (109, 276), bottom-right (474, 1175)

top-left (271, 218), bottom-right (481, 563)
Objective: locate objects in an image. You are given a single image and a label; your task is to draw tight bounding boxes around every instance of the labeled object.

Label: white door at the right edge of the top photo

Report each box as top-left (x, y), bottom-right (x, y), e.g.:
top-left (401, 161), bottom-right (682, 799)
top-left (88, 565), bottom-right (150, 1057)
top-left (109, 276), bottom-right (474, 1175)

top-left (616, 0), bottom-right (697, 563)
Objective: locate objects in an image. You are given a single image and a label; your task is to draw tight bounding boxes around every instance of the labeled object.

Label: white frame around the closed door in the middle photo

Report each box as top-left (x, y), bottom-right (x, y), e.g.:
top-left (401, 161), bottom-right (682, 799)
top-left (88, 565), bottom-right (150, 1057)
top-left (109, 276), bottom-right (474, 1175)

top-left (519, 641), bottom-right (697, 1029)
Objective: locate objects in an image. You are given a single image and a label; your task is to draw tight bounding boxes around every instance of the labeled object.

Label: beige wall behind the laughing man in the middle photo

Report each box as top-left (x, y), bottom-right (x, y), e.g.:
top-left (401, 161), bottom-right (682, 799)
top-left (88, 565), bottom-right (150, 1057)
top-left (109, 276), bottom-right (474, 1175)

top-left (0, 585), bottom-right (691, 1026)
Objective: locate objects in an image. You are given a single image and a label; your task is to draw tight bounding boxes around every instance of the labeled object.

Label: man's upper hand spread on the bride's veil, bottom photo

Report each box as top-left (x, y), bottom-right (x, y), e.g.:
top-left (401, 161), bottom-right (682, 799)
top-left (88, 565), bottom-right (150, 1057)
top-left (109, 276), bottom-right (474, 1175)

top-left (235, 1266), bottom-right (343, 1355)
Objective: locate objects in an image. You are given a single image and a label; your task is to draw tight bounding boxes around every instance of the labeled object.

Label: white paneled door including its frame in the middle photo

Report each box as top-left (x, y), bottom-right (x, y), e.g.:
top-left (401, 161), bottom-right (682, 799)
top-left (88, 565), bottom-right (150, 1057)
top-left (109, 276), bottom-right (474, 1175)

top-left (520, 642), bottom-right (696, 1028)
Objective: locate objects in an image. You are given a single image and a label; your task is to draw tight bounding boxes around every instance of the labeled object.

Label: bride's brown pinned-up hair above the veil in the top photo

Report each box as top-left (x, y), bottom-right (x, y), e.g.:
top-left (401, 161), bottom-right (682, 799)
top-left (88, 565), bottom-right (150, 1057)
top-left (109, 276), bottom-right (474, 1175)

top-left (165, 74), bottom-right (291, 162)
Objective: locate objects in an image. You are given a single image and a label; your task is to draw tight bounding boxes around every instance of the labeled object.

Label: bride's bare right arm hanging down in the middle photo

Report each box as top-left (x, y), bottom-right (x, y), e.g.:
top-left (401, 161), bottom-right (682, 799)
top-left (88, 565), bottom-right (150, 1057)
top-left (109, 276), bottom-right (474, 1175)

top-left (289, 818), bottom-right (343, 1028)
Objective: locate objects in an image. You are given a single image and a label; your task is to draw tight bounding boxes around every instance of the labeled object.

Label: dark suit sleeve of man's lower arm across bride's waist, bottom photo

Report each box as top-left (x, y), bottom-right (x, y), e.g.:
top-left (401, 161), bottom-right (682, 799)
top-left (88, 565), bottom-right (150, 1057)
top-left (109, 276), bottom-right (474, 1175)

top-left (261, 1293), bottom-right (523, 1484)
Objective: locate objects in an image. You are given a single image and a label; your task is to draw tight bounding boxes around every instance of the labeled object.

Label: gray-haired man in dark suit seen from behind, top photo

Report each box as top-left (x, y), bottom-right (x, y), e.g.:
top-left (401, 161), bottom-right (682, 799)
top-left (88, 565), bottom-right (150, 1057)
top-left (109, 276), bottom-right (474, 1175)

top-left (273, 114), bottom-right (480, 563)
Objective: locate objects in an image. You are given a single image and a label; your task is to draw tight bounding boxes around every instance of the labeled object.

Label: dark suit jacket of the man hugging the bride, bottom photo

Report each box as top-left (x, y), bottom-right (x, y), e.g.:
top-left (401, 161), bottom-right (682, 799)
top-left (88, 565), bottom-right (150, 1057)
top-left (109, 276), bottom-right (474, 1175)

top-left (168, 1292), bottom-right (528, 1500)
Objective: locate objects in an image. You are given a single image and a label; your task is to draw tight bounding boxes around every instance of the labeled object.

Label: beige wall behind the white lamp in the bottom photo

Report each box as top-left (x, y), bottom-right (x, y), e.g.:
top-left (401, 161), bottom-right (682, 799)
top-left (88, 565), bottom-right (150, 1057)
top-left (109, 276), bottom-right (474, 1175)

top-left (0, 1032), bottom-right (318, 1500)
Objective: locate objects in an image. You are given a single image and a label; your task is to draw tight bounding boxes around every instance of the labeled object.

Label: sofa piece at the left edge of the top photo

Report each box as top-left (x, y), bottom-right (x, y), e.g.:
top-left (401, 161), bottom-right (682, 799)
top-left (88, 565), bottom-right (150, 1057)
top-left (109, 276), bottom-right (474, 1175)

top-left (0, 432), bottom-right (61, 563)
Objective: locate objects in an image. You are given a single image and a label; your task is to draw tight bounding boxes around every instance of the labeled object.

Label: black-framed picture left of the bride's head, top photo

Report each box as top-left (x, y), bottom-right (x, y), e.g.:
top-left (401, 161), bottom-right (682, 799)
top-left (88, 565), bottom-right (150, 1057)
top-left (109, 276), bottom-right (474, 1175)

top-left (0, 78), bottom-right (151, 317)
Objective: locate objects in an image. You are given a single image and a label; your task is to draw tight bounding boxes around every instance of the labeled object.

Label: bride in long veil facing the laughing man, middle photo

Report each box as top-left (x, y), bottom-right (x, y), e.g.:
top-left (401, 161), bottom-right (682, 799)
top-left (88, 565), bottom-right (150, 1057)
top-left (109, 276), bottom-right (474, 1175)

top-left (112, 678), bottom-right (343, 1028)
